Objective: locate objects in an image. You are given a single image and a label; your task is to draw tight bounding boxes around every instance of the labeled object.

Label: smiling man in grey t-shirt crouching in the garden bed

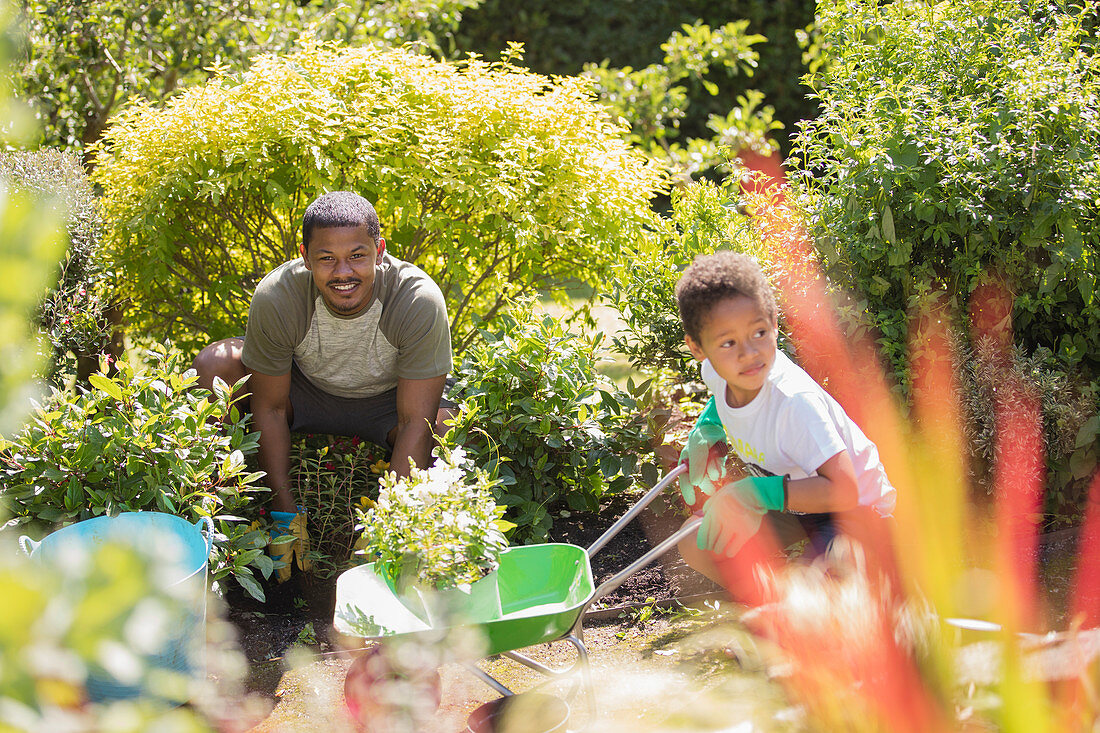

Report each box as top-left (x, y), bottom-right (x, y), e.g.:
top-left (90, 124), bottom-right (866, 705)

top-left (195, 192), bottom-right (454, 580)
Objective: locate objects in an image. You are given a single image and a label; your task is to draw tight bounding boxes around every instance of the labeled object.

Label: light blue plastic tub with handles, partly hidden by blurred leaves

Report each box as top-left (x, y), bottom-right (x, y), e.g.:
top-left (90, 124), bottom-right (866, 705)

top-left (19, 512), bottom-right (213, 702)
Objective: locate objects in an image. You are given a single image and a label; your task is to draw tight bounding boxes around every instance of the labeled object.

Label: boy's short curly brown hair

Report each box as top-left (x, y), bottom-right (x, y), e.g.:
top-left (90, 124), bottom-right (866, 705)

top-left (677, 250), bottom-right (779, 341)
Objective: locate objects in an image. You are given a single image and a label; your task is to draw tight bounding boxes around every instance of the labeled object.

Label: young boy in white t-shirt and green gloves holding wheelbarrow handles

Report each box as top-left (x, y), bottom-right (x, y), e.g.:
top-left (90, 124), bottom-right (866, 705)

top-left (677, 252), bottom-right (894, 582)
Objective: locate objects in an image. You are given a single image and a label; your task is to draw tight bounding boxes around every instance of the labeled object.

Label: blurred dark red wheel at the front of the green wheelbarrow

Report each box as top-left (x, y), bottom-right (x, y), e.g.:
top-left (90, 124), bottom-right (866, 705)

top-left (344, 645), bottom-right (442, 733)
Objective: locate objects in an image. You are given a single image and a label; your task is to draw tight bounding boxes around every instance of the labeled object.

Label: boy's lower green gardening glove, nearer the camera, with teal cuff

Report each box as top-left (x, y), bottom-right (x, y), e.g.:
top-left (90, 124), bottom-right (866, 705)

top-left (696, 475), bottom-right (787, 557)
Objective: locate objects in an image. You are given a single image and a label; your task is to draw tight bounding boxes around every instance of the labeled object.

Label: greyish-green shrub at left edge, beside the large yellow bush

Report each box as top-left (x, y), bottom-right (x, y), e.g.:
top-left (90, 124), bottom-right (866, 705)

top-left (0, 149), bottom-right (112, 387)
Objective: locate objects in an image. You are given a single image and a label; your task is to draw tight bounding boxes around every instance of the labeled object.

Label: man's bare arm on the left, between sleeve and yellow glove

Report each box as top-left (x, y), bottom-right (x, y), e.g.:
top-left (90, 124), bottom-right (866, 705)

top-left (249, 372), bottom-right (298, 513)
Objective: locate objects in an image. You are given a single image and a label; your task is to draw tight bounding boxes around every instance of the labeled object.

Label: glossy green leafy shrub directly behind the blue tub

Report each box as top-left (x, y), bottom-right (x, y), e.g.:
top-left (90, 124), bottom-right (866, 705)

top-left (0, 351), bottom-right (273, 600)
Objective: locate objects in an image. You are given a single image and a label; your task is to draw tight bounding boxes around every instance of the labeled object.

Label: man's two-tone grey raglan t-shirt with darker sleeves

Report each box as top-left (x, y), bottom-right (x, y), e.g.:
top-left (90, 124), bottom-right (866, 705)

top-left (241, 254), bottom-right (451, 397)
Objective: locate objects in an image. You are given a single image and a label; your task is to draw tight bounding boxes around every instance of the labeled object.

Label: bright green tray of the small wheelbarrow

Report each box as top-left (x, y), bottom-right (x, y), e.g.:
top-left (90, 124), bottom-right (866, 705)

top-left (333, 543), bottom-right (595, 656)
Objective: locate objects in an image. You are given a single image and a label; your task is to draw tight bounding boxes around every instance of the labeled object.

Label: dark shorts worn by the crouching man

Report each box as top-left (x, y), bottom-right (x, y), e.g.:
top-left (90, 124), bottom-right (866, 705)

top-left (290, 364), bottom-right (457, 446)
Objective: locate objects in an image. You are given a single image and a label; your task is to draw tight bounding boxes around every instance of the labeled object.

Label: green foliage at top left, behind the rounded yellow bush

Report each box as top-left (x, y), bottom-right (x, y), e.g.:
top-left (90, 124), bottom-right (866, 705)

top-left (14, 0), bottom-right (479, 153)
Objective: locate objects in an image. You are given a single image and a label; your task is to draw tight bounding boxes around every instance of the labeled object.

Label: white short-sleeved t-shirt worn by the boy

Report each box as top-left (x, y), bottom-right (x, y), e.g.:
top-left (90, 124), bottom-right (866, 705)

top-left (703, 350), bottom-right (897, 516)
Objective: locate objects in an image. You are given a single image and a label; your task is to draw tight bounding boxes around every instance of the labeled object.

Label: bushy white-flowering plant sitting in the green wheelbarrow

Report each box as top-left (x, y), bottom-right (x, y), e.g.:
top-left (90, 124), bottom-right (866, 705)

top-left (356, 447), bottom-right (515, 589)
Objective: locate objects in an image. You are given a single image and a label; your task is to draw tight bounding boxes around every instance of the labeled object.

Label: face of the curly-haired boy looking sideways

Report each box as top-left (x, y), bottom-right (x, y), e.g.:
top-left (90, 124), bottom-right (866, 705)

top-left (684, 295), bottom-right (779, 407)
